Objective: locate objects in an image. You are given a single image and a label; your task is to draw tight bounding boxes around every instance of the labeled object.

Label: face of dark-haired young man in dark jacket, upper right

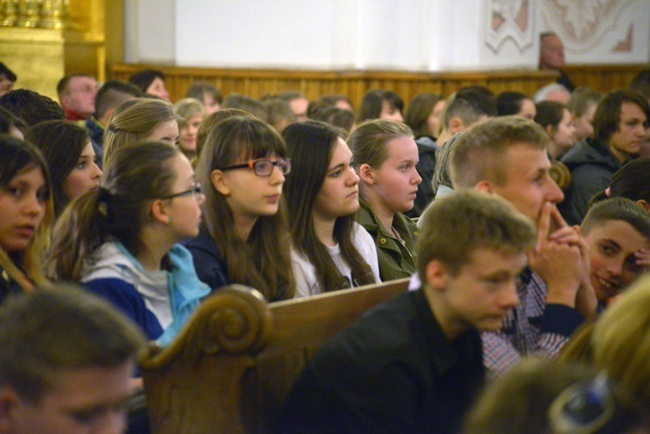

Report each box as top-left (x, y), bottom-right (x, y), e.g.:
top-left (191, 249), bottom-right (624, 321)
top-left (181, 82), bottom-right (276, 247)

top-left (608, 102), bottom-right (648, 161)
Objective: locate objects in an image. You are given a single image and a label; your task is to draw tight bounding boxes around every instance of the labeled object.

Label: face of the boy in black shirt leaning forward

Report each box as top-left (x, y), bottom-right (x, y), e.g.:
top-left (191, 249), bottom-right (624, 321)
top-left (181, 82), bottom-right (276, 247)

top-left (436, 248), bottom-right (526, 336)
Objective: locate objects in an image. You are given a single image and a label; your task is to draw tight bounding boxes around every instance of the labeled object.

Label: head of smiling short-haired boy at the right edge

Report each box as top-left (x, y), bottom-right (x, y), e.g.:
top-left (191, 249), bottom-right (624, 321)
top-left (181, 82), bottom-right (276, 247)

top-left (580, 197), bottom-right (650, 305)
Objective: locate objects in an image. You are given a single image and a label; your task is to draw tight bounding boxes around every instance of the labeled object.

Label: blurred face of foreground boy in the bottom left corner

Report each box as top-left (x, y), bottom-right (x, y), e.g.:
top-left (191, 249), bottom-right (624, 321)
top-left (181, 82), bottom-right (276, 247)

top-left (0, 363), bottom-right (133, 434)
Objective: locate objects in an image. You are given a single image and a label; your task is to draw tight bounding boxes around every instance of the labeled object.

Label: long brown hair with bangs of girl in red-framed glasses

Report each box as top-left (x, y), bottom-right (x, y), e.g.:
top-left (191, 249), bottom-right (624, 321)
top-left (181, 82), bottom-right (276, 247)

top-left (196, 116), bottom-right (295, 301)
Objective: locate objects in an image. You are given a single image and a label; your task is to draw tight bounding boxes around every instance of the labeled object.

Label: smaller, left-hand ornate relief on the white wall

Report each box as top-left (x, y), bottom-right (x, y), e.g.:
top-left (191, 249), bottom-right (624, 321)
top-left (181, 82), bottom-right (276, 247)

top-left (485, 0), bottom-right (533, 53)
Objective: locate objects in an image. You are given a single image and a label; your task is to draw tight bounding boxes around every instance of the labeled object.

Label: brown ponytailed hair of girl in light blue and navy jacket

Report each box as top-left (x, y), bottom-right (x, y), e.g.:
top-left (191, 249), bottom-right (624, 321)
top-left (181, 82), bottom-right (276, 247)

top-left (48, 142), bottom-right (181, 281)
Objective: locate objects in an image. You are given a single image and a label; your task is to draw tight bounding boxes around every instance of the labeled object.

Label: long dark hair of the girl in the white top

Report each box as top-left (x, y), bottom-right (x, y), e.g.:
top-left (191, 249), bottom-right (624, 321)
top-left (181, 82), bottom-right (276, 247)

top-left (283, 121), bottom-right (375, 292)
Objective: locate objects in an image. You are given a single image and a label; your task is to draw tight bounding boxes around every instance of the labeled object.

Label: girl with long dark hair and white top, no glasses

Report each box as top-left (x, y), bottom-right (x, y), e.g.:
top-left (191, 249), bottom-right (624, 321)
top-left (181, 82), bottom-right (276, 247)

top-left (283, 121), bottom-right (379, 297)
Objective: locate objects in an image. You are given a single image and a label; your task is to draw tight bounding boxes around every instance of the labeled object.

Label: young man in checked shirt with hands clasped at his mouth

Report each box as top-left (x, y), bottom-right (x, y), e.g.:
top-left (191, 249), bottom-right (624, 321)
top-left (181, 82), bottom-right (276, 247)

top-left (450, 116), bottom-right (598, 377)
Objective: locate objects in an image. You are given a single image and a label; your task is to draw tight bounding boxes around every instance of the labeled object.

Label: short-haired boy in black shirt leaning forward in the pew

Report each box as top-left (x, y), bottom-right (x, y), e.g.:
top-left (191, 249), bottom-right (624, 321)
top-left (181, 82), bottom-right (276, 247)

top-left (278, 192), bottom-right (536, 433)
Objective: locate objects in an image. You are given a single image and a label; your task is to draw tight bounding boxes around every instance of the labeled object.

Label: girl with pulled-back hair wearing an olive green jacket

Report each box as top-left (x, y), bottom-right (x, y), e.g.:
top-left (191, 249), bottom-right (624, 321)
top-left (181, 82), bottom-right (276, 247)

top-left (348, 119), bottom-right (422, 281)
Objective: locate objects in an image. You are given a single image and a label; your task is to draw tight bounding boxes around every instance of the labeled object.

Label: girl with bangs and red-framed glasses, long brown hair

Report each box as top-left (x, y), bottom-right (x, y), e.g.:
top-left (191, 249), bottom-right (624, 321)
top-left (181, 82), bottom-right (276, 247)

top-left (186, 116), bottom-right (294, 301)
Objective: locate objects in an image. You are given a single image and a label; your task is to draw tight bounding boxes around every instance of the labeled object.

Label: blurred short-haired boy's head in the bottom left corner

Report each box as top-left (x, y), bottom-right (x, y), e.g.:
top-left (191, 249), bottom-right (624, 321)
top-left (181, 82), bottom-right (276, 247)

top-left (0, 285), bottom-right (144, 434)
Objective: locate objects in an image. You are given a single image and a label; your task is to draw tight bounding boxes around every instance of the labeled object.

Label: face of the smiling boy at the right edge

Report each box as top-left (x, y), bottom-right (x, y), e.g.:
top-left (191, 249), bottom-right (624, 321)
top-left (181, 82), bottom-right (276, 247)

top-left (585, 220), bottom-right (650, 302)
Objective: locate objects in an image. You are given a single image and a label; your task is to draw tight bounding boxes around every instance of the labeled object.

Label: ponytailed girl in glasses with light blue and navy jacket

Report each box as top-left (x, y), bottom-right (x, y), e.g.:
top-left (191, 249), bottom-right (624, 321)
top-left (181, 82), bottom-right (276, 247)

top-left (48, 142), bottom-right (209, 346)
